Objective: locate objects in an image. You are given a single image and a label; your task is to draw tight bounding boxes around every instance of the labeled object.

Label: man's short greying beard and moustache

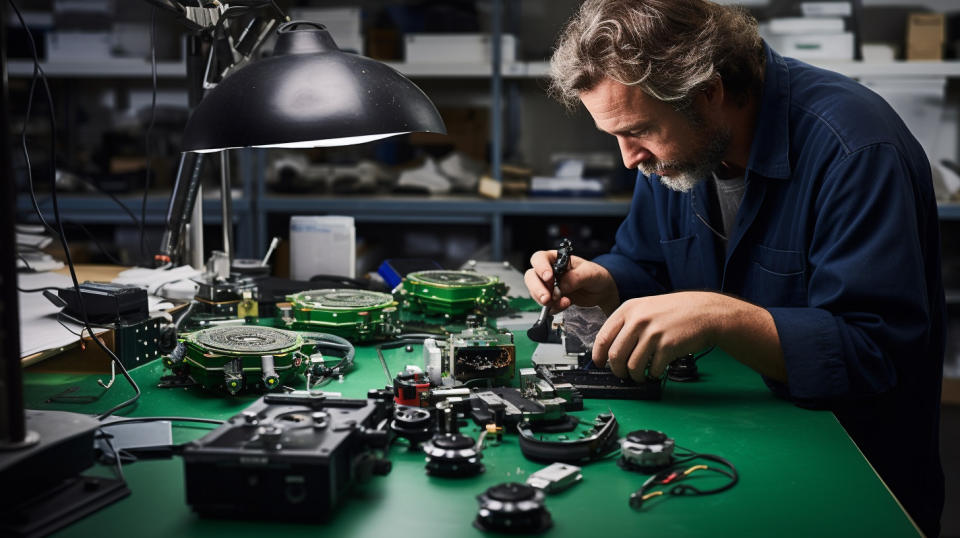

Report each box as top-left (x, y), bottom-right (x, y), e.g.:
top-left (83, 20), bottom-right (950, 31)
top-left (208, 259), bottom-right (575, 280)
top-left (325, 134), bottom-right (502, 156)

top-left (637, 111), bottom-right (732, 192)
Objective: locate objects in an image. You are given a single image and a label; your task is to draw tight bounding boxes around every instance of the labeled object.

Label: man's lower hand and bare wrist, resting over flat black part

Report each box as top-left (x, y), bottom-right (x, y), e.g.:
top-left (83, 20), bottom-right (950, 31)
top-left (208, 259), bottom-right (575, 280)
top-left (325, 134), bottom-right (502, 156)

top-left (592, 294), bottom-right (787, 382)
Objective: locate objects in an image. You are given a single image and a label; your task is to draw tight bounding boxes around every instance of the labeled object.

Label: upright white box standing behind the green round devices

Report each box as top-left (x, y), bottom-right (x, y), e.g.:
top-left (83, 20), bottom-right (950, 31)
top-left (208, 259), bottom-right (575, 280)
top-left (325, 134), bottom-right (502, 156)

top-left (290, 215), bottom-right (357, 280)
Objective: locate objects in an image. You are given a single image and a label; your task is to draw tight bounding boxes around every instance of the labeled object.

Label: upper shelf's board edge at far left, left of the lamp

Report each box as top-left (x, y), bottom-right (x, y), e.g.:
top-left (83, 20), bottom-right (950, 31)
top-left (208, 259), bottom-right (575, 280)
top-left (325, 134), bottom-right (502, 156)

top-left (7, 58), bottom-right (187, 78)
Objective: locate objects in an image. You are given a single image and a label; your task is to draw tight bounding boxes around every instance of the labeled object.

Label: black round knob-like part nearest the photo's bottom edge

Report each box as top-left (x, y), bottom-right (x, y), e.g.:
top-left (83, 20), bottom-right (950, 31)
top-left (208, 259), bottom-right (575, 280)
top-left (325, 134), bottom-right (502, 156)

top-left (473, 482), bottom-right (553, 534)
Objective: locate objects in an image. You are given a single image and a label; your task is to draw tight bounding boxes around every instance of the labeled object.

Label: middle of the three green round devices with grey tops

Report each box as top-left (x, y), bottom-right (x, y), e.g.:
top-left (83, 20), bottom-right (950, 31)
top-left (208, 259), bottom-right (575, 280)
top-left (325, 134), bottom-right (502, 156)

top-left (287, 289), bottom-right (401, 342)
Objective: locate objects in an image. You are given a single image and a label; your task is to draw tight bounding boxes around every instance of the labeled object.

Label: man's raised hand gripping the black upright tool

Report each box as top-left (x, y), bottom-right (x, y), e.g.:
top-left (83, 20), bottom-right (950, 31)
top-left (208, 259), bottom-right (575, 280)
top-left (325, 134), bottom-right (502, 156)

top-left (523, 250), bottom-right (620, 315)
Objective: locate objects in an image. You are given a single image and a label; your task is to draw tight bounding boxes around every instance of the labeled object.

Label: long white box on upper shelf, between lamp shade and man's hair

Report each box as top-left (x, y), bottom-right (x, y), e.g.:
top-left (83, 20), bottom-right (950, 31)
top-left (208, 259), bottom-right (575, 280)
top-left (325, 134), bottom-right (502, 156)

top-left (404, 34), bottom-right (517, 64)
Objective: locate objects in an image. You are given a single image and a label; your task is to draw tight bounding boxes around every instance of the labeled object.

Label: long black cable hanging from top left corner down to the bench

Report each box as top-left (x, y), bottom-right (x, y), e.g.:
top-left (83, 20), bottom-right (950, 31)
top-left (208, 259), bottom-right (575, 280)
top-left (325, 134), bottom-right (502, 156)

top-left (8, 0), bottom-right (140, 418)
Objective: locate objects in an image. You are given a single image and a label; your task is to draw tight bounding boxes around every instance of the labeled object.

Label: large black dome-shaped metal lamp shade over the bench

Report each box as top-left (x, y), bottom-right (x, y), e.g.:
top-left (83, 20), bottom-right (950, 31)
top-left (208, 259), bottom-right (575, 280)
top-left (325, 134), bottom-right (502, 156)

top-left (183, 21), bottom-right (446, 152)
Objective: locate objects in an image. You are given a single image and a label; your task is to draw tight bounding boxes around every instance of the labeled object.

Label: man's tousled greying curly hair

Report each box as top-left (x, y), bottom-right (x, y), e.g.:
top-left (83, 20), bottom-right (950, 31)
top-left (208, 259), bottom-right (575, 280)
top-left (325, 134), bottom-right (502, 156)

top-left (549, 0), bottom-right (764, 109)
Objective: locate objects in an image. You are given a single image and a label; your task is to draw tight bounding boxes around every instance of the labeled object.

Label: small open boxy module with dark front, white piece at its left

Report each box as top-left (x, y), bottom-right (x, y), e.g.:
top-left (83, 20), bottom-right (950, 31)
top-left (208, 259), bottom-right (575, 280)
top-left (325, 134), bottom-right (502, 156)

top-left (423, 323), bottom-right (517, 386)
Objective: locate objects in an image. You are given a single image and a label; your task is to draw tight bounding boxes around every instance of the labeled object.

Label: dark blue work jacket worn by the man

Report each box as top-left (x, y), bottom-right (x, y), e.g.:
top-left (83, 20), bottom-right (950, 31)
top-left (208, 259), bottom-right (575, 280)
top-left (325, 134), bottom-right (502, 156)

top-left (595, 47), bottom-right (946, 532)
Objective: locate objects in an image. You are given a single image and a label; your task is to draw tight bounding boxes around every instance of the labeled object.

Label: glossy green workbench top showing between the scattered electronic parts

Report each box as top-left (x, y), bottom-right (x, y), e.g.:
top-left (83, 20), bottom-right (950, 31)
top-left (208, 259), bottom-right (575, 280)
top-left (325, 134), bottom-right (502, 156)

top-left (18, 334), bottom-right (918, 538)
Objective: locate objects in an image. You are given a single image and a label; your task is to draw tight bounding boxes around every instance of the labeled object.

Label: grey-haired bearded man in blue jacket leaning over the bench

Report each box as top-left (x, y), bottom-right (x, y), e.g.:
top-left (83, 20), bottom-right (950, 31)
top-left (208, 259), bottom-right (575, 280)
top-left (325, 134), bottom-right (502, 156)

top-left (525, 0), bottom-right (945, 535)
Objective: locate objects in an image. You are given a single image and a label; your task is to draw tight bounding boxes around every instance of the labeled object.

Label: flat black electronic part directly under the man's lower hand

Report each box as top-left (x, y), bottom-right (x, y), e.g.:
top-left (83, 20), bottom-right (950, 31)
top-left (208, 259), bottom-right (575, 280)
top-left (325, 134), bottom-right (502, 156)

top-left (537, 366), bottom-right (666, 400)
